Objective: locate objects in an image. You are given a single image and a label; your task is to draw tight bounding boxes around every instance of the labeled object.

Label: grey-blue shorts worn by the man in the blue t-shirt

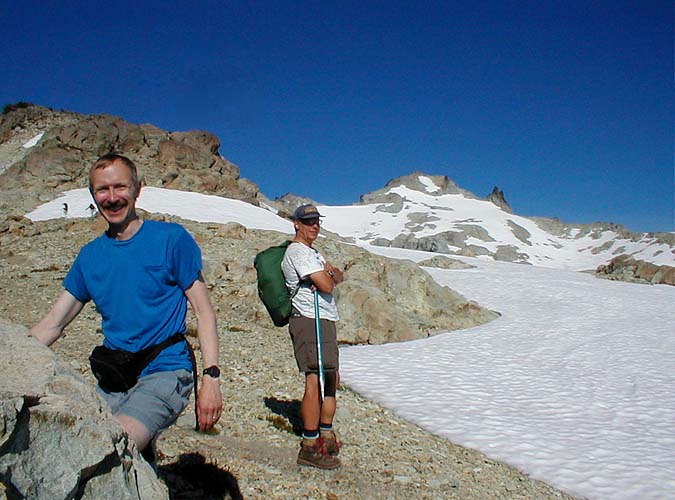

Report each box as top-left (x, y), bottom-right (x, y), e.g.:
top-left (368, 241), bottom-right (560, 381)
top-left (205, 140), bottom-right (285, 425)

top-left (96, 370), bottom-right (194, 436)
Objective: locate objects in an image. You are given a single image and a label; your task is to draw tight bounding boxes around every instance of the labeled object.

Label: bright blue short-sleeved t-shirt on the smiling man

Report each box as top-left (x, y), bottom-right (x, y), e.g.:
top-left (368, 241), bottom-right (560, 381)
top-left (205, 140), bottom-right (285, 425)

top-left (63, 221), bottom-right (202, 375)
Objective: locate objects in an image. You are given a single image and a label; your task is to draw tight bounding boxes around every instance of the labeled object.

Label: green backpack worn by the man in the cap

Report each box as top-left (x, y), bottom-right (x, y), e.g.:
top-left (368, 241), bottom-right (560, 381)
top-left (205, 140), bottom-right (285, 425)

top-left (253, 241), bottom-right (292, 326)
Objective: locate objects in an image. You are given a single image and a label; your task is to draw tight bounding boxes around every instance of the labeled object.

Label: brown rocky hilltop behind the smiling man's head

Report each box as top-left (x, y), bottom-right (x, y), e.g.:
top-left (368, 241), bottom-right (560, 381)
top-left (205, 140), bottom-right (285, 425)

top-left (0, 106), bottom-right (258, 213)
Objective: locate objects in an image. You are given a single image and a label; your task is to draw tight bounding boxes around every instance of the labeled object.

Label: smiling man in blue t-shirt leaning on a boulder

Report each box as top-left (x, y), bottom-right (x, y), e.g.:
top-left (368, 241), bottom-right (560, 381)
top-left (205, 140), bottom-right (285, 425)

top-left (31, 154), bottom-right (222, 462)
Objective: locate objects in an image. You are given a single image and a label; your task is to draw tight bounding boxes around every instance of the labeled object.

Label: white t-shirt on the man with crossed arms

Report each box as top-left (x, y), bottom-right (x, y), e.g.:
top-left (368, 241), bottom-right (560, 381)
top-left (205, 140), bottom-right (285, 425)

top-left (281, 242), bottom-right (340, 321)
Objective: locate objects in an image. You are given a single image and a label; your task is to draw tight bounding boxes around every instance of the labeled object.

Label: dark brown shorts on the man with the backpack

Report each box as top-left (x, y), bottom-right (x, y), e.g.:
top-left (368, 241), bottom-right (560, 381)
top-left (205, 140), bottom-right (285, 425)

top-left (288, 309), bottom-right (340, 373)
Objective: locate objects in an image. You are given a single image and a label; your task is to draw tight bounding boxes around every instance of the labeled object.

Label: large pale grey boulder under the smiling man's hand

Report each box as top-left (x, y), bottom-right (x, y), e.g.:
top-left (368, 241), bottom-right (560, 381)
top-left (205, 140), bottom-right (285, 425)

top-left (0, 321), bottom-right (169, 500)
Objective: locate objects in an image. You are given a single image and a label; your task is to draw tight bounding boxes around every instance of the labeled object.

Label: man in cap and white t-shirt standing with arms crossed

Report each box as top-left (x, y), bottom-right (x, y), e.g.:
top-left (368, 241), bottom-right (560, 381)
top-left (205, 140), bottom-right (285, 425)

top-left (281, 205), bottom-right (342, 469)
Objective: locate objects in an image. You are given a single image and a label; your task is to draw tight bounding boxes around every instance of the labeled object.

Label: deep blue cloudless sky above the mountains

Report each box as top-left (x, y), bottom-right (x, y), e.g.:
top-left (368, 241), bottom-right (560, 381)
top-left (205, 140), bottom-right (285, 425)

top-left (0, 0), bottom-right (675, 231)
